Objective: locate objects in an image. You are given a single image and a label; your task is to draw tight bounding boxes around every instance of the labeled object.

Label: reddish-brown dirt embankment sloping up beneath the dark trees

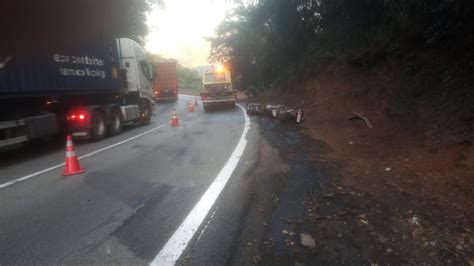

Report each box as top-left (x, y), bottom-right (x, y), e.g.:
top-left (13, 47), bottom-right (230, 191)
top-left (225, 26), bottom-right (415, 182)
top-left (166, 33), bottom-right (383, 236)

top-left (260, 56), bottom-right (474, 265)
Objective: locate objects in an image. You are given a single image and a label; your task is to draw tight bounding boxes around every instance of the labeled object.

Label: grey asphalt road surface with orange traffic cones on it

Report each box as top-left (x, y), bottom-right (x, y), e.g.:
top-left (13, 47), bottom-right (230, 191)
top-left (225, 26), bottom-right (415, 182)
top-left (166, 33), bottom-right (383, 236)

top-left (0, 96), bottom-right (254, 265)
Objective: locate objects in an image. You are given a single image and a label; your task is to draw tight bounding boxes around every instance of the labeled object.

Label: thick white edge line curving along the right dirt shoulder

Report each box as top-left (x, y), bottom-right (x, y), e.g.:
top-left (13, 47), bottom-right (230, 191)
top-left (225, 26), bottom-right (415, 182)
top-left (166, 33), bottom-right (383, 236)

top-left (150, 105), bottom-right (250, 266)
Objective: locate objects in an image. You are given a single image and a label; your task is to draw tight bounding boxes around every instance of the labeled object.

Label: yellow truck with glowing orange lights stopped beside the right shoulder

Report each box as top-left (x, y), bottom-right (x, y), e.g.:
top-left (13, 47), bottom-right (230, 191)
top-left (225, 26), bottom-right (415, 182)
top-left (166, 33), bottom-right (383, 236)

top-left (200, 65), bottom-right (236, 111)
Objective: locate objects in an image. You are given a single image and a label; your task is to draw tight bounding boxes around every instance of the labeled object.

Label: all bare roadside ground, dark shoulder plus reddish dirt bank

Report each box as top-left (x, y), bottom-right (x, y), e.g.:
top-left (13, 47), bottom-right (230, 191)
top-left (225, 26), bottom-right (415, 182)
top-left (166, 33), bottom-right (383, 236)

top-left (230, 62), bottom-right (474, 266)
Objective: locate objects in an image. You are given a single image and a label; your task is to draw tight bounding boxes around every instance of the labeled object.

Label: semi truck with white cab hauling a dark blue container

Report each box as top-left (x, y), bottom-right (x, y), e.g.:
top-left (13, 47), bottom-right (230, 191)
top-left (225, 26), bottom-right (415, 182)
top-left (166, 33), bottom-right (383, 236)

top-left (0, 38), bottom-right (154, 147)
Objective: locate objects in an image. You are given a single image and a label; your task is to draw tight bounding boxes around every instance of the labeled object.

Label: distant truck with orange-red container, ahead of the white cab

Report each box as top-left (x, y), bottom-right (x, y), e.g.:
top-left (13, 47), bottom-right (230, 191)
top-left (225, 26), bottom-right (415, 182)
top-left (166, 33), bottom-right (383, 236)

top-left (154, 62), bottom-right (178, 102)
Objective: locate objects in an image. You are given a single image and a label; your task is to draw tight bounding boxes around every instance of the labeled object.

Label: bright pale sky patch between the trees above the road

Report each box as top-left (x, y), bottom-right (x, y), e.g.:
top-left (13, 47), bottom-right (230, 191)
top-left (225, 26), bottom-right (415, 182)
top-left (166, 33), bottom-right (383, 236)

top-left (146, 0), bottom-right (231, 67)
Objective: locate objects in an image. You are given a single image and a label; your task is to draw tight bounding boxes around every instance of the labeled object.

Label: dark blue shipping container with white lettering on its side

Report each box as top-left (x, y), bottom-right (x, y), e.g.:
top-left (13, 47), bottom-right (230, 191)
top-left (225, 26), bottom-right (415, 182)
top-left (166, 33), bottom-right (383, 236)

top-left (0, 41), bottom-right (123, 96)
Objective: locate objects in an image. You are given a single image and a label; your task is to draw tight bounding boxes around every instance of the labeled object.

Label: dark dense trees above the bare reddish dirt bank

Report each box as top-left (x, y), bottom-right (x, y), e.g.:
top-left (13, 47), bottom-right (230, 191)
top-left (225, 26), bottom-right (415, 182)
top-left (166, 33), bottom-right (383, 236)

top-left (211, 0), bottom-right (474, 136)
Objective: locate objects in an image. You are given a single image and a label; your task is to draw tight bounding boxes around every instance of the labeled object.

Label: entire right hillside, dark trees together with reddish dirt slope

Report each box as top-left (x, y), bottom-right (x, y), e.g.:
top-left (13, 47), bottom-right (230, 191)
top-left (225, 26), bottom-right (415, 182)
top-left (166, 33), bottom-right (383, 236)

top-left (213, 0), bottom-right (474, 264)
